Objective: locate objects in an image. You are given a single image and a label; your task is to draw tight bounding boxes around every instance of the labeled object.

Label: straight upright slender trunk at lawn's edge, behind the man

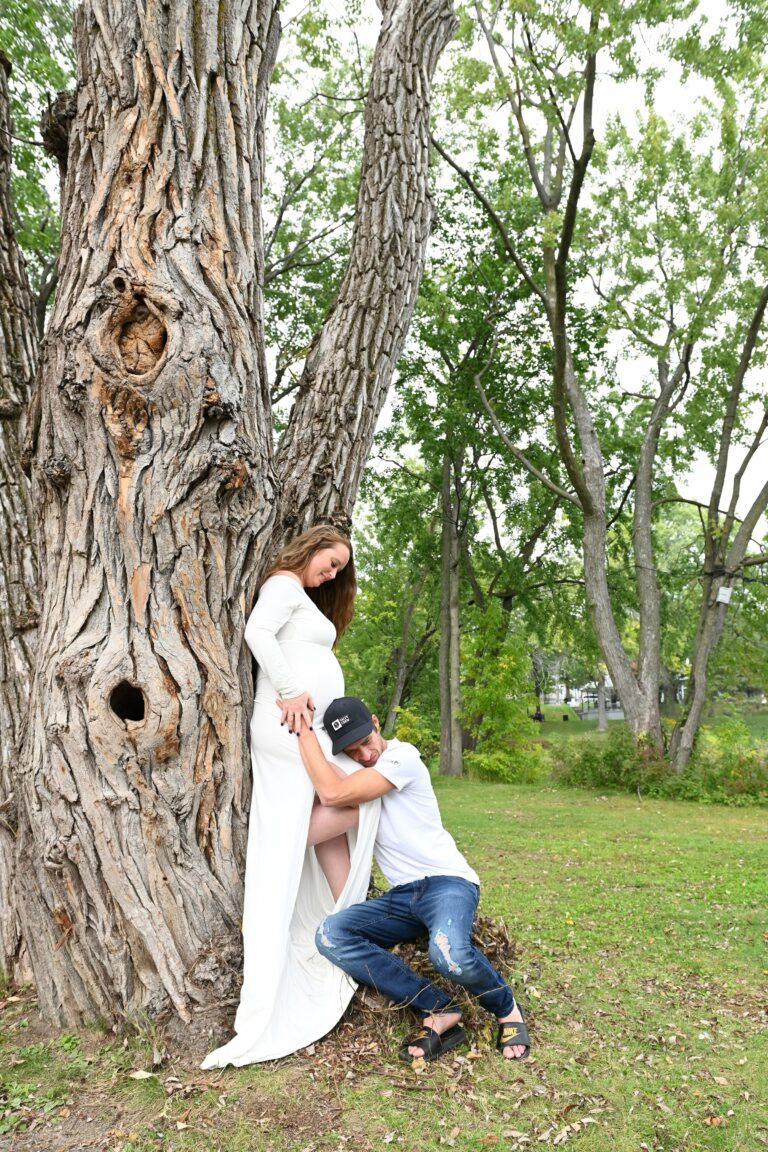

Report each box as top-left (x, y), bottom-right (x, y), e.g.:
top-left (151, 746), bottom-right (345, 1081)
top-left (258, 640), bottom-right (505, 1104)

top-left (440, 448), bottom-right (463, 776)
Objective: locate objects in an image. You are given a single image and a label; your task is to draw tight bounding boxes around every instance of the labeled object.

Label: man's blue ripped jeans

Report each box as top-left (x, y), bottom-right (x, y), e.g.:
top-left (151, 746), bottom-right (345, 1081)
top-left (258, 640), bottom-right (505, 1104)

top-left (315, 876), bottom-right (515, 1016)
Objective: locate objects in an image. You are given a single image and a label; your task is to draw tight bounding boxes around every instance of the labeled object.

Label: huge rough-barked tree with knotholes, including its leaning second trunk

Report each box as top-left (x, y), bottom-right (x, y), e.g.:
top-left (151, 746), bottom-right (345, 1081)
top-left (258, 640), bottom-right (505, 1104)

top-left (12, 0), bottom-right (453, 1023)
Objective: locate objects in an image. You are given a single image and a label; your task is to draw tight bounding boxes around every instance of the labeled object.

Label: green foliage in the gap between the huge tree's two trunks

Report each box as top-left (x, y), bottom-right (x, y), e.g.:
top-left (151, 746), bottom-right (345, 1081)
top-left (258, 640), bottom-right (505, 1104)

top-left (263, 5), bottom-right (367, 405)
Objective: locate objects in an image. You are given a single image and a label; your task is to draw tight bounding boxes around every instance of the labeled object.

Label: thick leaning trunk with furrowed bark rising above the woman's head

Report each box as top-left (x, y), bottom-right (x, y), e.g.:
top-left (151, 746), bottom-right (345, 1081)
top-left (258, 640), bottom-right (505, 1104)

top-left (277, 0), bottom-right (456, 535)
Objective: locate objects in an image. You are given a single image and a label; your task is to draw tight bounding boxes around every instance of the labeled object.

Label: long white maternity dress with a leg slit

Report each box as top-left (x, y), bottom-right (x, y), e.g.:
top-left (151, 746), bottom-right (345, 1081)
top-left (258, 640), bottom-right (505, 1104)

top-left (203, 576), bottom-right (380, 1068)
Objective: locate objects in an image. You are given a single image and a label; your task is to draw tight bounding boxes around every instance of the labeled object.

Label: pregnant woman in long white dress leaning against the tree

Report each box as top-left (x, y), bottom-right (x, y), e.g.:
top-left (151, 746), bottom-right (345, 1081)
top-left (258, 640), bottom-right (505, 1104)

top-left (203, 525), bottom-right (379, 1068)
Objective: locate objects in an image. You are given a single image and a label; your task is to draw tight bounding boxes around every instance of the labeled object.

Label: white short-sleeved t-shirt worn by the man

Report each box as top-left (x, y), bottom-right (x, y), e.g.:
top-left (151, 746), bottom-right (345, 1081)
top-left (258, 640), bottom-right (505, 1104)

top-left (373, 740), bottom-right (480, 887)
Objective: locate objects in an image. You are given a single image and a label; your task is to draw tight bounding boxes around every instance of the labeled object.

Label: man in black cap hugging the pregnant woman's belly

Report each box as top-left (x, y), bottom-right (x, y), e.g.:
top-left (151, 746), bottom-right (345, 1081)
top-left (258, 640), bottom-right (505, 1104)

top-left (292, 696), bottom-right (531, 1061)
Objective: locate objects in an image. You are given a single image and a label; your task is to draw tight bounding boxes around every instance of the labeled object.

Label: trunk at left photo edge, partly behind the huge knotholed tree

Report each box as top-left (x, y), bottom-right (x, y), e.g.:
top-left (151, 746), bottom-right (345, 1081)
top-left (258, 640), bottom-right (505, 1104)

top-left (0, 53), bottom-right (38, 979)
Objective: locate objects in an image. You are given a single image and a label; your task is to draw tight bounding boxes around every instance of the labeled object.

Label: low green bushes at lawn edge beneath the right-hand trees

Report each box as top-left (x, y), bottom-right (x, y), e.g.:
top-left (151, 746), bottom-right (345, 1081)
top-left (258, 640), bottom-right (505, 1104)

top-left (554, 717), bottom-right (768, 804)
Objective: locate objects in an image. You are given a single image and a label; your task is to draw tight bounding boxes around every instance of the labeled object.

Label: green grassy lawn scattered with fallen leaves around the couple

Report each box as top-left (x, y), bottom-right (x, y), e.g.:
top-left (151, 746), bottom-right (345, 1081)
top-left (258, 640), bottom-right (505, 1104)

top-left (0, 783), bottom-right (768, 1152)
